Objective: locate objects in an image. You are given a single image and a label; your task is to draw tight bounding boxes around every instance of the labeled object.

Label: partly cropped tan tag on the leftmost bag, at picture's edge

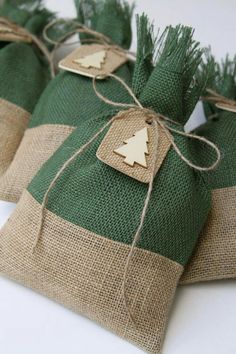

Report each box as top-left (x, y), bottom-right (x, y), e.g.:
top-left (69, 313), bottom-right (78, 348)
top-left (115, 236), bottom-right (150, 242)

top-left (0, 22), bottom-right (32, 43)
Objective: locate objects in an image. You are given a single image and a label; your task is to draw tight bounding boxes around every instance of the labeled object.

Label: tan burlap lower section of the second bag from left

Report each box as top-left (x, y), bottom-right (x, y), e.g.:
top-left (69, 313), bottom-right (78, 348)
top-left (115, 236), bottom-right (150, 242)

top-left (0, 124), bottom-right (74, 202)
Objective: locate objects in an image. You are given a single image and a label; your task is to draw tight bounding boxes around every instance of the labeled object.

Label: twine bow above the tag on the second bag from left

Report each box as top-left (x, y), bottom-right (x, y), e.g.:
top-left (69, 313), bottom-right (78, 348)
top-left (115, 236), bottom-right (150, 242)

top-left (43, 19), bottom-right (135, 74)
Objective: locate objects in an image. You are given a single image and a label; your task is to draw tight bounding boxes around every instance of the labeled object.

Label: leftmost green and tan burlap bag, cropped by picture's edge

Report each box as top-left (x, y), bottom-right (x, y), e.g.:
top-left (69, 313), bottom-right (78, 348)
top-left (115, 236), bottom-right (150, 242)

top-left (0, 0), bottom-right (53, 180)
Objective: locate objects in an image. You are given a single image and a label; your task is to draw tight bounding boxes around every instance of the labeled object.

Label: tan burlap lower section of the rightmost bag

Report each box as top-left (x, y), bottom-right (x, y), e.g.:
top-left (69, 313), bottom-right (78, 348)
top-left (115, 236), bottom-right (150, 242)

top-left (180, 187), bottom-right (236, 284)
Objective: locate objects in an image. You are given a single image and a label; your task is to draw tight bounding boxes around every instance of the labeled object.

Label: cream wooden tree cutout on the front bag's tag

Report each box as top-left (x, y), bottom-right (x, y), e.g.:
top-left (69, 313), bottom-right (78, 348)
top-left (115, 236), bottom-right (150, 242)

top-left (114, 128), bottom-right (149, 168)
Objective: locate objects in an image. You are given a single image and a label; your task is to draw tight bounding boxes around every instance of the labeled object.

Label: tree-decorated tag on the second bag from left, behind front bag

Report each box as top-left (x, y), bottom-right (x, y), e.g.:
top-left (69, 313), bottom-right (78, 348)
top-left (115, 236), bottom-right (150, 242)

top-left (59, 44), bottom-right (128, 79)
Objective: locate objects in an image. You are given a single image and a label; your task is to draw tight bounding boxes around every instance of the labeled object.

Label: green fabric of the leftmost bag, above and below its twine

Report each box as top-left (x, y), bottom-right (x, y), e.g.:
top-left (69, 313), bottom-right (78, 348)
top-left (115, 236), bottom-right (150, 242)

top-left (0, 0), bottom-right (52, 113)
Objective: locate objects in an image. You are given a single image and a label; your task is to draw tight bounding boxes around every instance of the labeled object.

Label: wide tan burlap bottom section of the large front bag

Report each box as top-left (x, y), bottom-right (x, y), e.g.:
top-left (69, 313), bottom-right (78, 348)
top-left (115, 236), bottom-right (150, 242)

top-left (0, 191), bottom-right (183, 353)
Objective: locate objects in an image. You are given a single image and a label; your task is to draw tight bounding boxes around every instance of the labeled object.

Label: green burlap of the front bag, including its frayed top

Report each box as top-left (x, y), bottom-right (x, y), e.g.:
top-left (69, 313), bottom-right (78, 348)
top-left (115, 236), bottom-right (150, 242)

top-left (29, 27), bottom-right (210, 265)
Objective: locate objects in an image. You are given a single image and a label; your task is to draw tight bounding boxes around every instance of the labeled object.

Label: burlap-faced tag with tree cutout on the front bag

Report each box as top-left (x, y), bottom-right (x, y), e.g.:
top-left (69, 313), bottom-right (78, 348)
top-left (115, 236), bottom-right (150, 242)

top-left (97, 109), bottom-right (171, 183)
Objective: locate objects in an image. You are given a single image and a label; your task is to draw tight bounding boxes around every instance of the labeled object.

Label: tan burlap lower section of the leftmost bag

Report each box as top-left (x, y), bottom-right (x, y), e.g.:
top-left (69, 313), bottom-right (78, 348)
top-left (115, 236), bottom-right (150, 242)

top-left (0, 99), bottom-right (30, 176)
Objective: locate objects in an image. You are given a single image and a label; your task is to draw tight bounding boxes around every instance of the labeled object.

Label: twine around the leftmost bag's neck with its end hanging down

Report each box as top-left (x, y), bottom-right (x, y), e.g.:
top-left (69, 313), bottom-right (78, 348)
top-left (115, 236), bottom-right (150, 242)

top-left (0, 17), bottom-right (55, 78)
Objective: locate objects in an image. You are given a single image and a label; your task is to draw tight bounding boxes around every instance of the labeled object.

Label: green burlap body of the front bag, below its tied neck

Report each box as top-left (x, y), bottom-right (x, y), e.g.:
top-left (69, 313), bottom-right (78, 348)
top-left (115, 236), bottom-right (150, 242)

top-left (29, 124), bottom-right (210, 265)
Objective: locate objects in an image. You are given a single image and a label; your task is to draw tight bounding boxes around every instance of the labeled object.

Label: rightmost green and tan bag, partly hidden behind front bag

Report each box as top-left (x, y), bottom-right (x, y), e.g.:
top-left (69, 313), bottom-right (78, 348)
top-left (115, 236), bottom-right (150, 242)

top-left (181, 56), bottom-right (236, 284)
